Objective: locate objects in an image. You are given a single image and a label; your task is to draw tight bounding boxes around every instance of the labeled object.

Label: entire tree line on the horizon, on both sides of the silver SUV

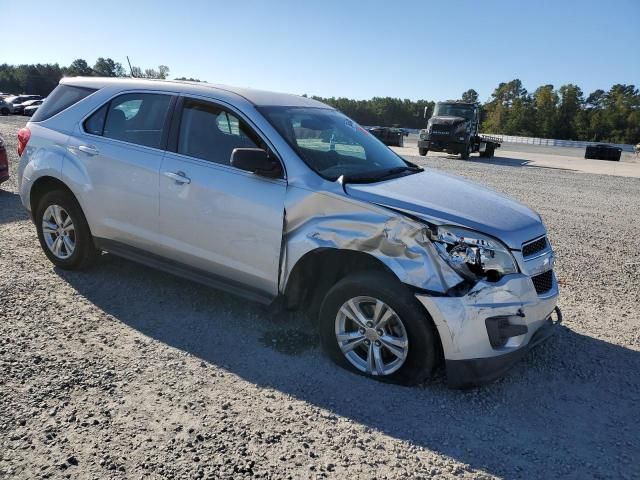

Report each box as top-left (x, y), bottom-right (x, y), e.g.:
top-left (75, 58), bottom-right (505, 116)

top-left (0, 57), bottom-right (640, 144)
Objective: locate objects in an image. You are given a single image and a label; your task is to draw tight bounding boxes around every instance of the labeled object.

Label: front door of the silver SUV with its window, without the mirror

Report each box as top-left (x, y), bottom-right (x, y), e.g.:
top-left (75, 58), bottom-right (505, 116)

top-left (159, 98), bottom-right (286, 296)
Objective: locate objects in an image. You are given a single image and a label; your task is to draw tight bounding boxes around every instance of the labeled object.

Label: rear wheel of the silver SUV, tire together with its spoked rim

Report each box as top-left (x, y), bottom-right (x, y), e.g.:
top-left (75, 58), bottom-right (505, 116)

top-left (34, 190), bottom-right (99, 270)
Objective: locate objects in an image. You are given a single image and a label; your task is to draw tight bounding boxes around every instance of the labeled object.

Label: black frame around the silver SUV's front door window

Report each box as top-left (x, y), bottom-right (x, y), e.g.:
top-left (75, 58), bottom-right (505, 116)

top-left (166, 93), bottom-right (287, 181)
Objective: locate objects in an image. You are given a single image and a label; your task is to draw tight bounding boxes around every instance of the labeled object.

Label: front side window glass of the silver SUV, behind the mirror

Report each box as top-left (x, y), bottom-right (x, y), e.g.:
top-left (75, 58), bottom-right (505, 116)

top-left (178, 100), bottom-right (261, 165)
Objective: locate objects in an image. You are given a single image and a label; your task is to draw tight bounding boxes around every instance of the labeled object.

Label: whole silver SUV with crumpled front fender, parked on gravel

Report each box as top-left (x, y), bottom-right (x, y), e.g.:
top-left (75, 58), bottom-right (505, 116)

top-left (13, 78), bottom-right (560, 387)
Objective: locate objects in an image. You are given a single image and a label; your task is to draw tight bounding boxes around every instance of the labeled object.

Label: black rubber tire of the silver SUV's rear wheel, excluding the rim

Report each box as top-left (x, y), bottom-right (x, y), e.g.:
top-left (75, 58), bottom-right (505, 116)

top-left (34, 190), bottom-right (95, 270)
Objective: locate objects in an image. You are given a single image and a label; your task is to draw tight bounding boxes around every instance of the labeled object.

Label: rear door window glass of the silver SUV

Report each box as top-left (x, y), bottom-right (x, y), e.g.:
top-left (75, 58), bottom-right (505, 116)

top-left (84, 93), bottom-right (171, 148)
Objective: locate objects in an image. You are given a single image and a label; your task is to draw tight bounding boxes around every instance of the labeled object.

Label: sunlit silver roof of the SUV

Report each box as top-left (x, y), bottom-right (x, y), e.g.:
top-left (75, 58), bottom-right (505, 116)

top-left (60, 77), bottom-right (331, 108)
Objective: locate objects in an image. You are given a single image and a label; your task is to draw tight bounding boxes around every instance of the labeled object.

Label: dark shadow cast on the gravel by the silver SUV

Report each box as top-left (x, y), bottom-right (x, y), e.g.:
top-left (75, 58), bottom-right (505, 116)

top-left (58, 255), bottom-right (640, 478)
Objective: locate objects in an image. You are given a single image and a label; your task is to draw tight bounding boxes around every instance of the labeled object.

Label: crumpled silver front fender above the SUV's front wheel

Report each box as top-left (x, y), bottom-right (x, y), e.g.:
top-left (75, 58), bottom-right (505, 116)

top-left (280, 187), bottom-right (462, 294)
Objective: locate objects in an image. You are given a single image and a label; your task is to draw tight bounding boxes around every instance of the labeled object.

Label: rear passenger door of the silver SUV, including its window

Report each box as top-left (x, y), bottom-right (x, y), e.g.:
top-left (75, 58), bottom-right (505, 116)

top-left (69, 91), bottom-right (175, 251)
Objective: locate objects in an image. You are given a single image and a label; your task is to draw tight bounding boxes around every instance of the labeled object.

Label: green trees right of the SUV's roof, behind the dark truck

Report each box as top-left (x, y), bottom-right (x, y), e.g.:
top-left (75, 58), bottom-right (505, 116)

top-left (313, 79), bottom-right (640, 144)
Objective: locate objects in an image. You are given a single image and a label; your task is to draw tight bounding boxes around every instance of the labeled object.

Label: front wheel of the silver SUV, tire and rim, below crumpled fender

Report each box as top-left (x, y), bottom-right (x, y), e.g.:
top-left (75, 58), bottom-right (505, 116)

top-left (319, 272), bottom-right (439, 385)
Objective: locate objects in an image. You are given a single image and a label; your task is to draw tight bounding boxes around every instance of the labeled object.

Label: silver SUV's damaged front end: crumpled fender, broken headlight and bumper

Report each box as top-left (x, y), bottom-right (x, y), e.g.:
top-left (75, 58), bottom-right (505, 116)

top-left (281, 189), bottom-right (558, 387)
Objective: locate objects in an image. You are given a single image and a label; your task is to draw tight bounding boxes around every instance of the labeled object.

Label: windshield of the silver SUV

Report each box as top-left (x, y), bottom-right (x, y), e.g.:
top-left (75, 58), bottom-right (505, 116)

top-left (260, 107), bottom-right (416, 181)
